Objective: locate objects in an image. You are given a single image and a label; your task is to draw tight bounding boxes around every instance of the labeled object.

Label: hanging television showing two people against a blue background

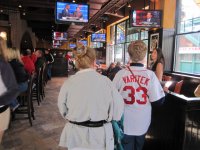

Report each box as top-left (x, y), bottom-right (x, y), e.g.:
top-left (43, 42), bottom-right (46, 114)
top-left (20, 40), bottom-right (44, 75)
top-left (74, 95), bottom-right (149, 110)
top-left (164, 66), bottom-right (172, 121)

top-left (55, 2), bottom-right (89, 23)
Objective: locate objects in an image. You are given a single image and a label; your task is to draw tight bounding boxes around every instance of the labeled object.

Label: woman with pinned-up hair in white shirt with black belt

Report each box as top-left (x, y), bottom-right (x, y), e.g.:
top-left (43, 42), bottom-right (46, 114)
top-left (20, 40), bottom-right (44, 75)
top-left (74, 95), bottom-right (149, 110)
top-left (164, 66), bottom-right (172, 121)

top-left (58, 46), bottom-right (124, 150)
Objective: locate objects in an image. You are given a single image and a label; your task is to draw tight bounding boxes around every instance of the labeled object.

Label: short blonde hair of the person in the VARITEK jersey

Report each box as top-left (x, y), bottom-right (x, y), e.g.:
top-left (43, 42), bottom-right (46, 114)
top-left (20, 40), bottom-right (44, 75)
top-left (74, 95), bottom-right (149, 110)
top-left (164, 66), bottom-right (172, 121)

top-left (128, 40), bottom-right (147, 62)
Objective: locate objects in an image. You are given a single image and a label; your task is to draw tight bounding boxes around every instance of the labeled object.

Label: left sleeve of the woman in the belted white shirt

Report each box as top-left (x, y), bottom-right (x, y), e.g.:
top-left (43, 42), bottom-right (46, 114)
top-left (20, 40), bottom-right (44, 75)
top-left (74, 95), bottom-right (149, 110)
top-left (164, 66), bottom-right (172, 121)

top-left (58, 81), bottom-right (69, 118)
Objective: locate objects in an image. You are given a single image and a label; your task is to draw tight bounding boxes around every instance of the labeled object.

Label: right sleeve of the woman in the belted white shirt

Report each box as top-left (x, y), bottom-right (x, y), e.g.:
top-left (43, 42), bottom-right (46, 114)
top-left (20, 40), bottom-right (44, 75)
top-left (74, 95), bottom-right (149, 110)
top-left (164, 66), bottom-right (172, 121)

top-left (111, 83), bottom-right (124, 121)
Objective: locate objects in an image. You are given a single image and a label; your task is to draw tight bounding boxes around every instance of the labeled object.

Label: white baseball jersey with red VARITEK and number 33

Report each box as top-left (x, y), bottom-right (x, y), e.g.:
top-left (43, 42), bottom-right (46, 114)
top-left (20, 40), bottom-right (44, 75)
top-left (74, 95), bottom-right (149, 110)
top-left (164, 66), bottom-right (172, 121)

top-left (113, 66), bottom-right (165, 136)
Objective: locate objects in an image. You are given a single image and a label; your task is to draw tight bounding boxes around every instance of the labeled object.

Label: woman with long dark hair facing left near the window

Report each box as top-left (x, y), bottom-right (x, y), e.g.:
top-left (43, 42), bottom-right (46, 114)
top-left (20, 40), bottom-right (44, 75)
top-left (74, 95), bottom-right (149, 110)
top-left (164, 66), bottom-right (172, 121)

top-left (151, 48), bottom-right (165, 81)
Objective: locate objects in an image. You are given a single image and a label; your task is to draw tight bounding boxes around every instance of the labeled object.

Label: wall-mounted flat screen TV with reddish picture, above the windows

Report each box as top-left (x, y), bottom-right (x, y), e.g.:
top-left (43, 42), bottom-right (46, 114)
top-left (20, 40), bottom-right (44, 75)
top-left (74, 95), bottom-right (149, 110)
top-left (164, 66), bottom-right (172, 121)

top-left (130, 10), bottom-right (162, 27)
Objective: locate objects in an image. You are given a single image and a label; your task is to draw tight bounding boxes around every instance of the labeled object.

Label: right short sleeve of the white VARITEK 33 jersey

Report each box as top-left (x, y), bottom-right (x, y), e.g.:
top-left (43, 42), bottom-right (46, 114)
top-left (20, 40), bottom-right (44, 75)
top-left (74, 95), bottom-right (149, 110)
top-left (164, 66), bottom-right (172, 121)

top-left (148, 72), bottom-right (165, 102)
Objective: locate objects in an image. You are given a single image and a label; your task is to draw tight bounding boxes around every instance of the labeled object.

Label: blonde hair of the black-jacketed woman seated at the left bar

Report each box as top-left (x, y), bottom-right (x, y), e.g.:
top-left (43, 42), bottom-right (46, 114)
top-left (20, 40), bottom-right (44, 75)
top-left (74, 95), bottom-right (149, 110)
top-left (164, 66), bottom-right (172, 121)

top-left (7, 48), bottom-right (22, 63)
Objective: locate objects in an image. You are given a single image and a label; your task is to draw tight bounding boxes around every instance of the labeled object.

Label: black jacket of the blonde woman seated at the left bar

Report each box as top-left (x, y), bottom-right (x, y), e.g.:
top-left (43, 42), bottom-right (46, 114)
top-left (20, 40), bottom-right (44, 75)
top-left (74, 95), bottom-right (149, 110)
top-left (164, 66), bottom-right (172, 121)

top-left (9, 59), bottom-right (29, 83)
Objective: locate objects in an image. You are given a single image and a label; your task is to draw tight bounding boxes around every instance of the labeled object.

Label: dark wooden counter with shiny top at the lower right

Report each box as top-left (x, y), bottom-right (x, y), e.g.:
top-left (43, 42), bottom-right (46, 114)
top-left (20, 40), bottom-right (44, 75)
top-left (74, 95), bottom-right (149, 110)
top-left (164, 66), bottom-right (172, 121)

top-left (144, 92), bottom-right (200, 150)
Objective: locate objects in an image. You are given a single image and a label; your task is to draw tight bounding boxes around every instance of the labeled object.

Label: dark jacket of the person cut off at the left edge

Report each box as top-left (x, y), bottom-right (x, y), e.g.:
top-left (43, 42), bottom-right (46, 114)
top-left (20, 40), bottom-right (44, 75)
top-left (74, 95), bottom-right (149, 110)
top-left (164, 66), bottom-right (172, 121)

top-left (0, 58), bottom-right (19, 106)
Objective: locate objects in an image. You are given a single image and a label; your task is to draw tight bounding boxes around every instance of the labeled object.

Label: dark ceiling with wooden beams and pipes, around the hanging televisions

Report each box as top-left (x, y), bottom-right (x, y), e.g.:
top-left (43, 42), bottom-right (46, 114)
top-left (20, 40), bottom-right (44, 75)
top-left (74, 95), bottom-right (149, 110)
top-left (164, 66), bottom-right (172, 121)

top-left (0, 0), bottom-right (150, 41)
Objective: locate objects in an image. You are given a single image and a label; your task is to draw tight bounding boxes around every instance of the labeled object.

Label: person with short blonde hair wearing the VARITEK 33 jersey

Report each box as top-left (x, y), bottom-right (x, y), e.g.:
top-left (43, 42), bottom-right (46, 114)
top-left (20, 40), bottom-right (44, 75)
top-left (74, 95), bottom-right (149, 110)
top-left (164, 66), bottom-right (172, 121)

top-left (113, 40), bottom-right (165, 150)
